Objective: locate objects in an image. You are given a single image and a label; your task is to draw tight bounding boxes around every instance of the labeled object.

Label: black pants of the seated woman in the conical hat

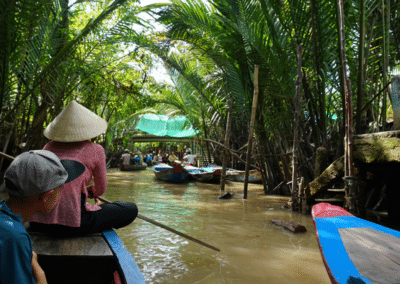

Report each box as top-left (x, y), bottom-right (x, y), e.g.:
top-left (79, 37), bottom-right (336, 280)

top-left (30, 194), bottom-right (138, 236)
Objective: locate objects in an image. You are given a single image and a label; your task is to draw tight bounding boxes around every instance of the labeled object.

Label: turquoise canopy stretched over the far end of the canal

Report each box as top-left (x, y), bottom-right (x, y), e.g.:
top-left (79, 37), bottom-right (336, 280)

top-left (135, 113), bottom-right (199, 137)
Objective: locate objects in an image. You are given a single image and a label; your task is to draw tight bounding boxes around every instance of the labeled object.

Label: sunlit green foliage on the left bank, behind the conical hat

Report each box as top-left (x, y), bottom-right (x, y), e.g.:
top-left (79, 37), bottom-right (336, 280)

top-left (0, 0), bottom-right (159, 153)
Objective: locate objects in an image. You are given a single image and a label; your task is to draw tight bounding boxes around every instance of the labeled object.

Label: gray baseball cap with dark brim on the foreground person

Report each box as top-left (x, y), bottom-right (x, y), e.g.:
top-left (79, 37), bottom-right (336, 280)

top-left (4, 150), bottom-right (85, 197)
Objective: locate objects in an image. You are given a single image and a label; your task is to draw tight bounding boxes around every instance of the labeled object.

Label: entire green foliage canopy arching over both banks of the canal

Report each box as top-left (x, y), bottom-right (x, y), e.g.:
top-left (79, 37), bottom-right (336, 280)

top-left (0, 0), bottom-right (400, 191)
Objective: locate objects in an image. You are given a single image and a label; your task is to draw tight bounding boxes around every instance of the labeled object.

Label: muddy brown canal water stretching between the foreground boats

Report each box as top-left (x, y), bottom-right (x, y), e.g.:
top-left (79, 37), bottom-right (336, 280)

top-left (104, 168), bottom-right (330, 284)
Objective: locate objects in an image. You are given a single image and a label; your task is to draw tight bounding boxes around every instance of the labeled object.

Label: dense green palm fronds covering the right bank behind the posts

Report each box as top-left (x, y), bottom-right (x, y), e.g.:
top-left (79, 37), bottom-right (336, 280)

top-left (149, 0), bottom-right (400, 191)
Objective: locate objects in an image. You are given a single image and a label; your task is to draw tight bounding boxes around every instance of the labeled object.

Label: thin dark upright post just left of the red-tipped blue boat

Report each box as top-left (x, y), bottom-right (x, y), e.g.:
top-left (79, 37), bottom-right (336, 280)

top-left (292, 45), bottom-right (303, 211)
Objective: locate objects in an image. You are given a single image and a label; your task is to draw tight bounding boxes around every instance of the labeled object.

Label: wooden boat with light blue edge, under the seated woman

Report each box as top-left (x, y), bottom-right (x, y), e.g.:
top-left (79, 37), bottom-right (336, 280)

top-left (28, 229), bottom-right (146, 284)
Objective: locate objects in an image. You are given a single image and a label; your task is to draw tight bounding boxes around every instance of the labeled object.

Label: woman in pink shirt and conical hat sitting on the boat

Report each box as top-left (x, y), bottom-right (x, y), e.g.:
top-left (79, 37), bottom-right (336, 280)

top-left (29, 101), bottom-right (138, 235)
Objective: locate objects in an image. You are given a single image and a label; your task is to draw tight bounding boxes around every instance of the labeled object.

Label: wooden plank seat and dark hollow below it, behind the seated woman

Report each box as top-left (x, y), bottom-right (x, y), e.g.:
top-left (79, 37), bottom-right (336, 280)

top-left (27, 228), bottom-right (117, 284)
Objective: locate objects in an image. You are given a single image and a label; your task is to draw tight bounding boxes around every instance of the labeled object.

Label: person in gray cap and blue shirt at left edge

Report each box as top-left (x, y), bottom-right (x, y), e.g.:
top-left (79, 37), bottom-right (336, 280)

top-left (0, 150), bottom-right (85, 284)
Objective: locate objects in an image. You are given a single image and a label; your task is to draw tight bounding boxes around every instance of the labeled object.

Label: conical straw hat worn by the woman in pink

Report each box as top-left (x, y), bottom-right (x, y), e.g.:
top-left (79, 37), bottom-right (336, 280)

top-left (43, 101), bottom-right (107, 142)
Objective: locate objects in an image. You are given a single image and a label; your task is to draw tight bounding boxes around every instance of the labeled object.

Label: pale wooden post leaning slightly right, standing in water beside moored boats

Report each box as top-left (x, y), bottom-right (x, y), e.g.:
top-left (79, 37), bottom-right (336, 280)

top-left (243, 65), bottom-right (263, 199)
